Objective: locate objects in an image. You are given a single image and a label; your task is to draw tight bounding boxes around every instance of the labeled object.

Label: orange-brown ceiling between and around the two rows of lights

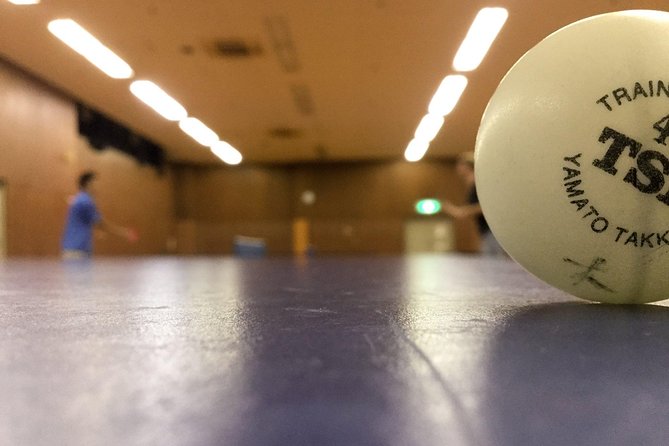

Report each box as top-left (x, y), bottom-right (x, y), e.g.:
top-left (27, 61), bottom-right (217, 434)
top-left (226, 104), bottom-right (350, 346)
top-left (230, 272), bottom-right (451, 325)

top-left (0, 0), bottom-right (668, 163)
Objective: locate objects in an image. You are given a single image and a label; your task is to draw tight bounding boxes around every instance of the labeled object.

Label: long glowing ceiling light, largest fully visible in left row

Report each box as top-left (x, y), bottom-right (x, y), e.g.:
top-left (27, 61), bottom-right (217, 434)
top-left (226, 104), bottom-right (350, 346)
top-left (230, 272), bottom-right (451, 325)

top-left (48, 19), bottom-right (134, 79)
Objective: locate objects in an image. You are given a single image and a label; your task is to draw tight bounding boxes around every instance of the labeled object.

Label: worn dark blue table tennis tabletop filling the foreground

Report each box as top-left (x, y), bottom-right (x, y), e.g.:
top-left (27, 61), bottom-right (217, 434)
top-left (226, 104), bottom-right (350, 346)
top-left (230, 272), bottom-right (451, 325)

top-left (0, 256), bottom-right (669, 446)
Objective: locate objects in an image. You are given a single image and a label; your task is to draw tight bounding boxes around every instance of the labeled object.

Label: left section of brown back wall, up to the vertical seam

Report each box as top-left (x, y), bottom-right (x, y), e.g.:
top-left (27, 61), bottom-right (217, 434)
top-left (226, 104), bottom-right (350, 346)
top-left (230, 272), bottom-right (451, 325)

top-left (173, 166), bottom-right (292, 254)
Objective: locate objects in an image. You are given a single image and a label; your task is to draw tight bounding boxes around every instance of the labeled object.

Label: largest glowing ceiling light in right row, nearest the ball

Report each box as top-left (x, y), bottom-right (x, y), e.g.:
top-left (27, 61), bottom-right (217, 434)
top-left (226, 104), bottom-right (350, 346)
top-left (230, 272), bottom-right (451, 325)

top-left (453, 8), bottom-right (509, 71)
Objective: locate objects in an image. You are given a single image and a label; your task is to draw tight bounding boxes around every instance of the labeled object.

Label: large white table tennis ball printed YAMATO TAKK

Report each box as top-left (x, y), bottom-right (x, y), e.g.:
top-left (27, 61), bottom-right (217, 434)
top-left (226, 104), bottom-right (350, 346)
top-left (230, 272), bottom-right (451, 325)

top-left (475, 11), bottom-right (669, 303)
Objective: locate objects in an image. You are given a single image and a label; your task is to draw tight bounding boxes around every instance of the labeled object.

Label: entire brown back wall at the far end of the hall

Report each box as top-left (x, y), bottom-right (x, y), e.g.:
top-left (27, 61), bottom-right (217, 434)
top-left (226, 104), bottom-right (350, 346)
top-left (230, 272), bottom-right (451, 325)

top-left (175, 161), bottom-right (478, 254)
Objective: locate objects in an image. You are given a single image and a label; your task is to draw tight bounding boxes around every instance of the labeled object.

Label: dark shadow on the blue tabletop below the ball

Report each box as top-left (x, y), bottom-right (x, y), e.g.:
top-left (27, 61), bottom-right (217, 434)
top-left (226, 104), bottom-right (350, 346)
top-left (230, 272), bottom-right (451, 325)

top-left (484, 303), bottom-right (669, 446)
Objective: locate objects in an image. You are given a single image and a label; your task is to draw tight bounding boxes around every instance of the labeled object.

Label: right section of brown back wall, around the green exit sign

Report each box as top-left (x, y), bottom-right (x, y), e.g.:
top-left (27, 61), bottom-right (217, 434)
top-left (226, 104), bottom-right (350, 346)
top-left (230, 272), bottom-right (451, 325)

top-left (292, 160), bottom-right (478, 254)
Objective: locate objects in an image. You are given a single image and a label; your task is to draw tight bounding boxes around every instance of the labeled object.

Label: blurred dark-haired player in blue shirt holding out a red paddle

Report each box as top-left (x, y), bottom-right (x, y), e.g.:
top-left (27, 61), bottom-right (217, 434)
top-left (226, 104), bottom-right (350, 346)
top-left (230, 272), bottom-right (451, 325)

top-left (62, 172), bottom-right (136, 259)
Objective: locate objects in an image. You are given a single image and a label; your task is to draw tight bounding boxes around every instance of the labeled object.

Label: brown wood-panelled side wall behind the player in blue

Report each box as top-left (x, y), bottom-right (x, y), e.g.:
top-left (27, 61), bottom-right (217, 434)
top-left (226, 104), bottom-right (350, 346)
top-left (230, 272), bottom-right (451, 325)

top-left (0, 57), bottom-right (174, 256)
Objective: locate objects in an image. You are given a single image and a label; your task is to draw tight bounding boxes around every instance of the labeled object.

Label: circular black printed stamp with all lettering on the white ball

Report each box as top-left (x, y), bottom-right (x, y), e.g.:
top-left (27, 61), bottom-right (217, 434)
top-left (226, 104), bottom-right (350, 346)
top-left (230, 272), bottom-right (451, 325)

top-left (562, 80), bottom-right (669, 249)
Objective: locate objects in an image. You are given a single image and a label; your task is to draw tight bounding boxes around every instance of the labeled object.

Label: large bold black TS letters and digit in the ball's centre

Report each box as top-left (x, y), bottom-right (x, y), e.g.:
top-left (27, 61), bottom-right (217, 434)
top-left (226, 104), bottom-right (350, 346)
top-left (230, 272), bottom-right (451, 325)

top-left (592, 115), bottom-right (669, 206)
